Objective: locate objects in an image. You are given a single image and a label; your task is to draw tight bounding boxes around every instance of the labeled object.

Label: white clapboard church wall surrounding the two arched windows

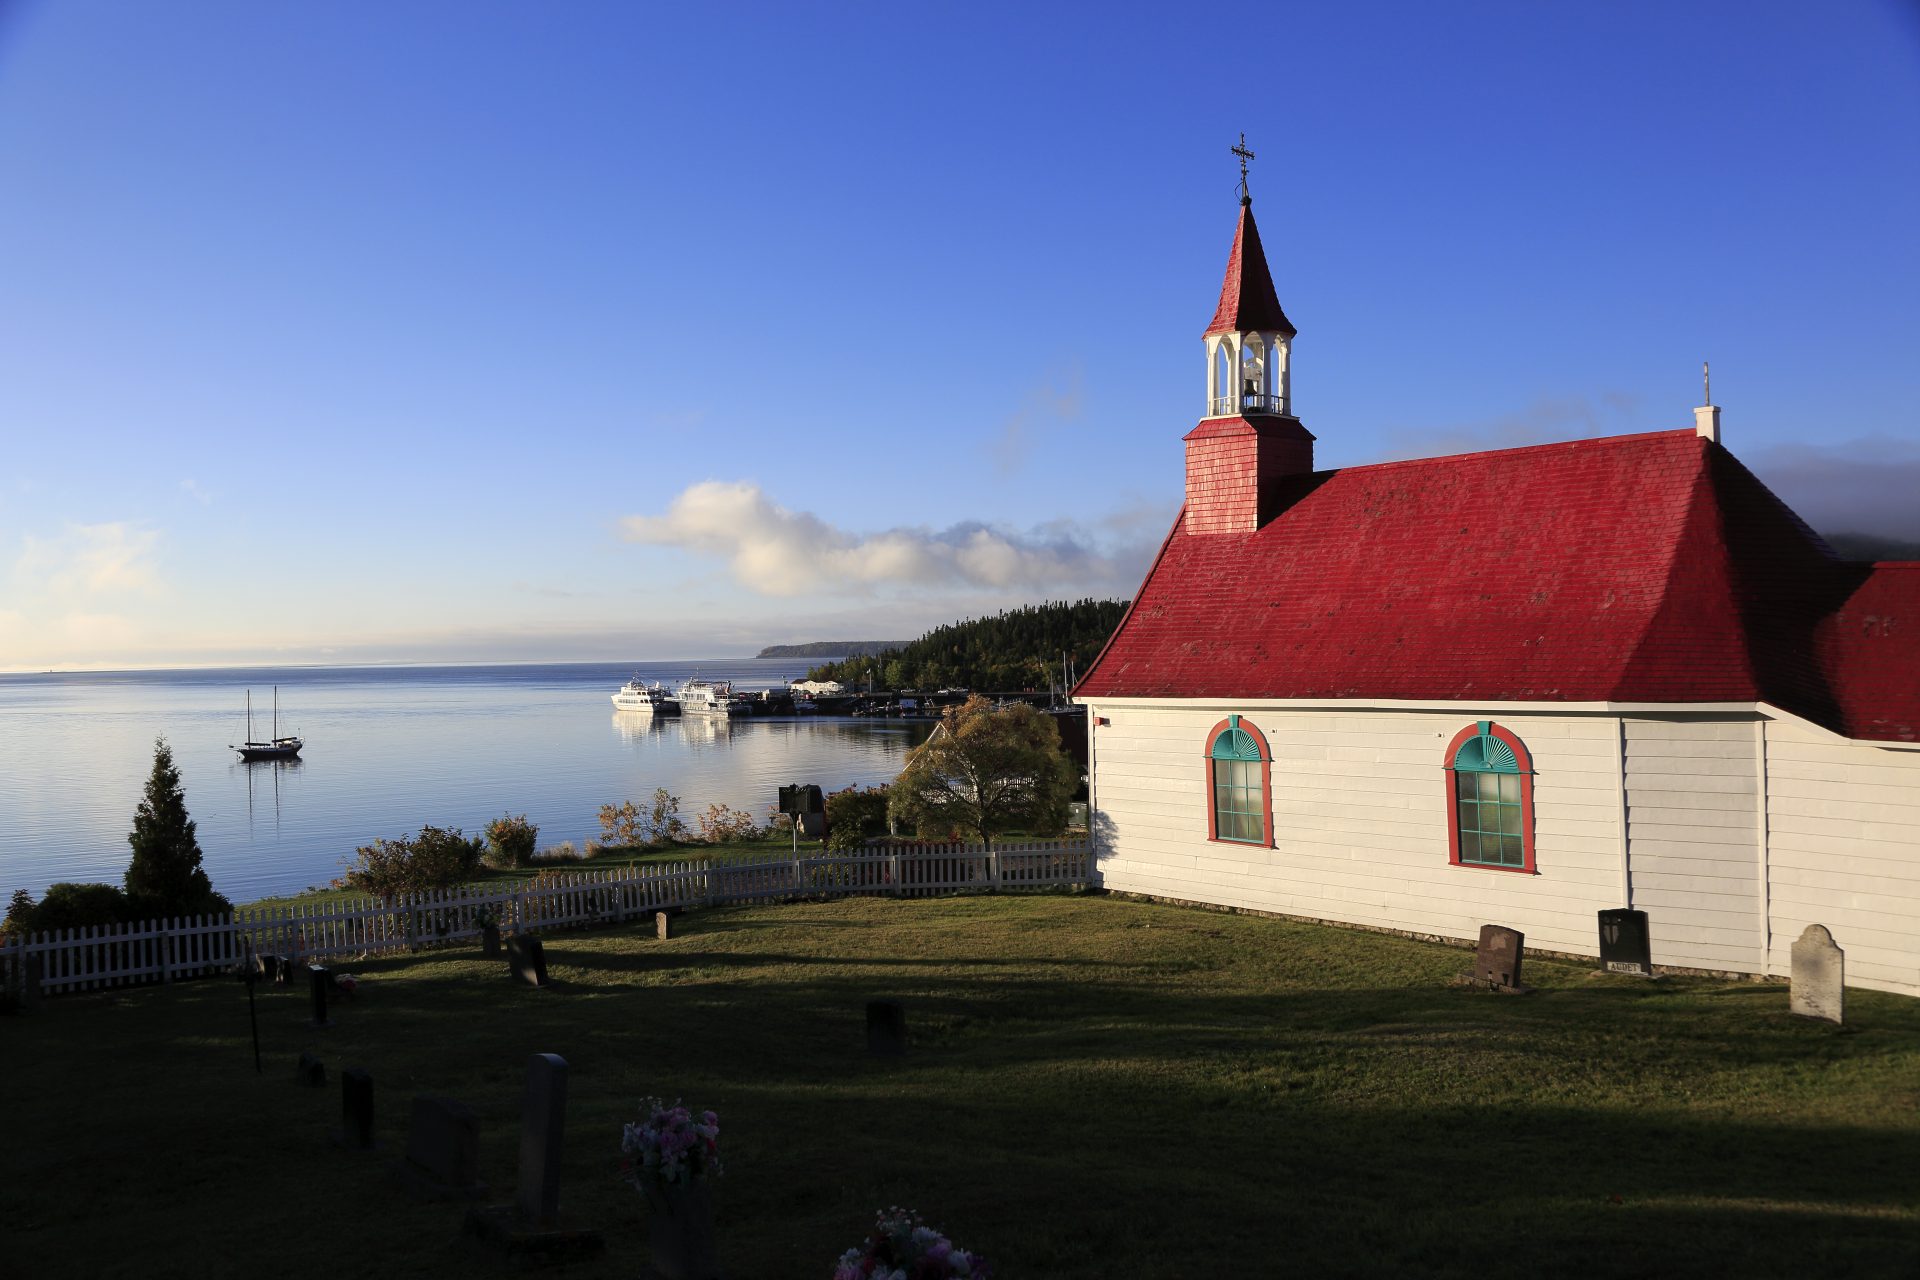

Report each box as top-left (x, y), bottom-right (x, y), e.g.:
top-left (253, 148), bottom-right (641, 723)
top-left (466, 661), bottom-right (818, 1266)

top-left (1094, 702), bottom-right (1620, 954)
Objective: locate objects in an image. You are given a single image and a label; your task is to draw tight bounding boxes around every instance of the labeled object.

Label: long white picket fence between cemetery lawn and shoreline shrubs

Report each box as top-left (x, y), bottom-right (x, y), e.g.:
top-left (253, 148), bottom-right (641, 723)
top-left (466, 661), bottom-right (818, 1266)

top-left (0, 837), bottom-right (1092, 994)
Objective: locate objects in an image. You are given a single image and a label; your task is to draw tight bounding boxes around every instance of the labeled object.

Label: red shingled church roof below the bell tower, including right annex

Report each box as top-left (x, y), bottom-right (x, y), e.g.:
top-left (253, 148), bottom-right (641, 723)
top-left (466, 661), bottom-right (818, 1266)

top-left (1075, 430), bottom-right (1920, 741)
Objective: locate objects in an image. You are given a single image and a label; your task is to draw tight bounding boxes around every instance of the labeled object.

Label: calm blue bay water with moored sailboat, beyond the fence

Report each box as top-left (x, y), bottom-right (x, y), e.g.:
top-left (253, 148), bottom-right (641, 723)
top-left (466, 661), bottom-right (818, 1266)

top-left (0, 658), bottom-right (931, 902)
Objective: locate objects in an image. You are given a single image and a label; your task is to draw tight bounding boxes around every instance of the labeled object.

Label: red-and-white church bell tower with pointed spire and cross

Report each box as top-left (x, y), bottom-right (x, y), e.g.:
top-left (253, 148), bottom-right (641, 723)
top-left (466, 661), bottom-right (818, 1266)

top-left (1187, 134), bottom-right (1313, 533)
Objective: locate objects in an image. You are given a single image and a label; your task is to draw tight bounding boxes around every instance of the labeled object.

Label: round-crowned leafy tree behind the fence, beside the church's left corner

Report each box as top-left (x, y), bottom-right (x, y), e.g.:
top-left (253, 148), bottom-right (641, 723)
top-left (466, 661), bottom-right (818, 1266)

top-left (887, 695), bottom-right (1077, 844)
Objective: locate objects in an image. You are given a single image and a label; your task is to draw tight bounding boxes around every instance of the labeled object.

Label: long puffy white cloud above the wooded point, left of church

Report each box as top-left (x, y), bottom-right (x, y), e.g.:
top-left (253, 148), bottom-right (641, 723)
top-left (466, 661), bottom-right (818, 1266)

top-left (620, 480), bottom-right (1150, 595)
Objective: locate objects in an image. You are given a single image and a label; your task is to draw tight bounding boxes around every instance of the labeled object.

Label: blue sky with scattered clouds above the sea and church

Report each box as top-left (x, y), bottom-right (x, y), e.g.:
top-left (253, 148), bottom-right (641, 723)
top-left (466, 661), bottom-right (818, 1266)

top-left (0, 0), bottom-right (1920, 670)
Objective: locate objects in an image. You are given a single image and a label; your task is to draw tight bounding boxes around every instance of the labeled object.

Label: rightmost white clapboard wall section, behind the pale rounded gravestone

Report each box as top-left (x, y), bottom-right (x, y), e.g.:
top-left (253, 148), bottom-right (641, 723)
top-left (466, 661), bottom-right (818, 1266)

top-left (1766, 720), bottom-right (1920, 994)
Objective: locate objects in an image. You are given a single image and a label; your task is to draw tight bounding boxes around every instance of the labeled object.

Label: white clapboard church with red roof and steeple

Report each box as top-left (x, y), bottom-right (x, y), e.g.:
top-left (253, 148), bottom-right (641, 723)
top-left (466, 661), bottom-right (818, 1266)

top-left (1075, 189), bottom-right (1920, 994)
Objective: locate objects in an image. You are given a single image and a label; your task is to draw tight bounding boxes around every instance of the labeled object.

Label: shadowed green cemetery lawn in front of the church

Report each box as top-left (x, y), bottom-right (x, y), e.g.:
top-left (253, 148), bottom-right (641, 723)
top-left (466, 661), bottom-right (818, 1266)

top-left (0, 894), bottom-right (1920, 1280)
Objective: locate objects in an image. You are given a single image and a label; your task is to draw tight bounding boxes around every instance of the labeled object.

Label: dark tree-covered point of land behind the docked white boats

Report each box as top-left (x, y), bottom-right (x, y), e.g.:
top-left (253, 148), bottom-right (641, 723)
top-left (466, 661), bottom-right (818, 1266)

top-left (806, 599), bottom-right (1127, 693)
